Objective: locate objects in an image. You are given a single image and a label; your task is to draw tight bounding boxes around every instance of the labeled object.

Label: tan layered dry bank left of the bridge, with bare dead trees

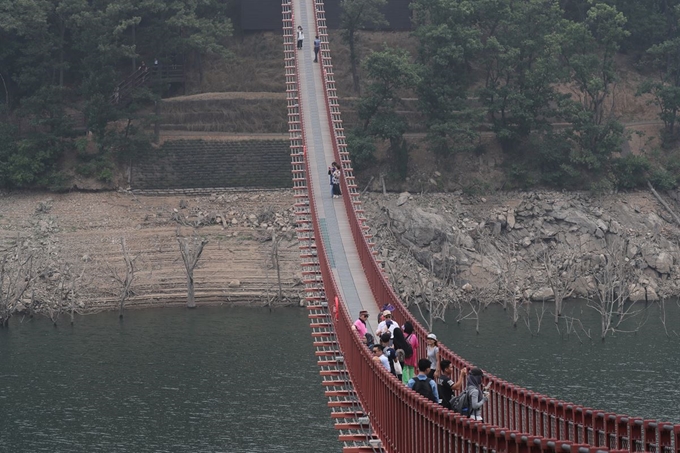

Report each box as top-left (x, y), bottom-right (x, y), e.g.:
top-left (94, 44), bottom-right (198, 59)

top-left (0, 191), bottom-right (301, 311)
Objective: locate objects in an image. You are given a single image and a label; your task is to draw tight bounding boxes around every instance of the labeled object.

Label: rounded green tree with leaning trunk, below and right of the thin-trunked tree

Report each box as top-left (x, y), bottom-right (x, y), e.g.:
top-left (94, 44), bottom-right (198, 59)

top-left (355, 47), bottom-right (419, 178)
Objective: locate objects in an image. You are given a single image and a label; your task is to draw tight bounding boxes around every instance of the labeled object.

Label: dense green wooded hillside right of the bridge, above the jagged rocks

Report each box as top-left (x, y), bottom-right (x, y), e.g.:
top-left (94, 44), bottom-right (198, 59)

top-left (349, 0), bottom-right (680, 192)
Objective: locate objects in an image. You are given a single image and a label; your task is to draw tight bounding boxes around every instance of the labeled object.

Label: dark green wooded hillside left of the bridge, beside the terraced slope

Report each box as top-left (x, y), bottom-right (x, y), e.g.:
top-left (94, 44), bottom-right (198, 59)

top-left (0, 0), bottom-right (235, 190)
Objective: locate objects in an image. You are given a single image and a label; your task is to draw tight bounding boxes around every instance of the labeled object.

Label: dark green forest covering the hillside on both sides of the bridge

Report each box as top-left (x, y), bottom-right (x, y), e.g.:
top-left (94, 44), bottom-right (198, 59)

top-left (0, 0), bottom-right (680, 192)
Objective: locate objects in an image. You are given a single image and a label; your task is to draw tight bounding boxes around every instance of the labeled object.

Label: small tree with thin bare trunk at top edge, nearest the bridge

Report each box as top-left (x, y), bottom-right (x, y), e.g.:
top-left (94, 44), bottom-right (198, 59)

top-left (340, 0), bottom-right (388, 94)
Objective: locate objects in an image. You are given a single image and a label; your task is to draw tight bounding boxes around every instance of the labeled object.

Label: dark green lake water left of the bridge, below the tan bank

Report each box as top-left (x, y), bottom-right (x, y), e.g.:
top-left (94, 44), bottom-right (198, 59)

top-left (0, 307), bottom-right (341, 452)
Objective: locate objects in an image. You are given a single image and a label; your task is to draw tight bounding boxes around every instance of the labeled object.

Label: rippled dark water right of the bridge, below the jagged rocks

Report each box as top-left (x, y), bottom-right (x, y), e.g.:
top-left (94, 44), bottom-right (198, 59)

top-left (434, 301), bottom-right (680, 423)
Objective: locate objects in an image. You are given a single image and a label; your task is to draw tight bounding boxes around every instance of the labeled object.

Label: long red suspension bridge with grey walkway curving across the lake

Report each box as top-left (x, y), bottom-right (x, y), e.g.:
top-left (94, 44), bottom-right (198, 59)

top-left (282, 0), bottom-right (680, 453)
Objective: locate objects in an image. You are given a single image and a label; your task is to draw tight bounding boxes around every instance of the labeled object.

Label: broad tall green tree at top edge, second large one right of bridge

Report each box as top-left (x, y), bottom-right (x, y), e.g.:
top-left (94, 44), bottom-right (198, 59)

top-left (476, 0), bottom-right (564, 150)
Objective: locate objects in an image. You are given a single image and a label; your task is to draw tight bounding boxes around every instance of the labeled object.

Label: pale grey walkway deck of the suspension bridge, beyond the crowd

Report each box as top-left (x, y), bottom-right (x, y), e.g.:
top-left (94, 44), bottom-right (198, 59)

top-left (293, 0), bottom-right (379, 332)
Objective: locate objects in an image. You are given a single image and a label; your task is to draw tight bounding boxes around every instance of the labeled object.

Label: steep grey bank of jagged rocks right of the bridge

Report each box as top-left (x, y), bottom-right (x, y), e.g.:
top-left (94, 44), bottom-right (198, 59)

top-left (365, 192), bottom-right (680, 303)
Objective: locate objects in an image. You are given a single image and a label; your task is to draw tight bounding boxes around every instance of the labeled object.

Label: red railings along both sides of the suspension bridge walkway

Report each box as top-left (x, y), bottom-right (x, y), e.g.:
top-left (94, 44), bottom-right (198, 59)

top-left (290, 0), bottom-right (680, 453)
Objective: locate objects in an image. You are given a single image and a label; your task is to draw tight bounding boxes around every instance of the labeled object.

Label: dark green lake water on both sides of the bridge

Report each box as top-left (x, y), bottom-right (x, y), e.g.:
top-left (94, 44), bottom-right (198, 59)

top-left (0, 302), bottom-right (680, 453)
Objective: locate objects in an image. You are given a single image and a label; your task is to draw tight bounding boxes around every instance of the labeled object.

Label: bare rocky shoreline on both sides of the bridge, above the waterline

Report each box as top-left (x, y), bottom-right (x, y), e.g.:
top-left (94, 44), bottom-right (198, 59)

top-left (0, 190), bottom-right (680, 324)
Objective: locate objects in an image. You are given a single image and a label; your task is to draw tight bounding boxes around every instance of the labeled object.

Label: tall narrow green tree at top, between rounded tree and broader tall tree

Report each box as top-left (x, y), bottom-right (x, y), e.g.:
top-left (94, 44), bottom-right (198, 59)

top-left (411, 0), bottom-right (482, 155)
